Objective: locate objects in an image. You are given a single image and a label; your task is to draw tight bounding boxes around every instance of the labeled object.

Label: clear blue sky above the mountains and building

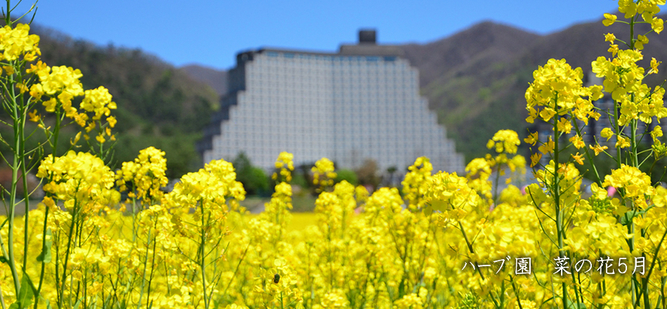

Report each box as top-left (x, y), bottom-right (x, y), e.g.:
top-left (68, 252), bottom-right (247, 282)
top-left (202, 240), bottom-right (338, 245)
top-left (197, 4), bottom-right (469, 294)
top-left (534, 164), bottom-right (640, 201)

top-left (17, 0), bottom-right (617, 69)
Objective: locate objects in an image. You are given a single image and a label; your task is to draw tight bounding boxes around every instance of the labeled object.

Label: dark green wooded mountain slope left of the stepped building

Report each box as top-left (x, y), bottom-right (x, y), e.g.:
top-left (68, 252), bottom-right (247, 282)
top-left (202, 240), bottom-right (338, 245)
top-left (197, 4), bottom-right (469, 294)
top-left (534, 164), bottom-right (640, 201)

top-left (32, 26), bottom-right (218, 177)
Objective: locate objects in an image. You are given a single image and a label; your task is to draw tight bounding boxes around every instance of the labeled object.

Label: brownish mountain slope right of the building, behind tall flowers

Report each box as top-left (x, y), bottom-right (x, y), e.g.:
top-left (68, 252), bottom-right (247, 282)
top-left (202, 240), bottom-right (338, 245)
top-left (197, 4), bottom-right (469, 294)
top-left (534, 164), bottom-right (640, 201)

top-left (404, 16), bottom-right (667, 160)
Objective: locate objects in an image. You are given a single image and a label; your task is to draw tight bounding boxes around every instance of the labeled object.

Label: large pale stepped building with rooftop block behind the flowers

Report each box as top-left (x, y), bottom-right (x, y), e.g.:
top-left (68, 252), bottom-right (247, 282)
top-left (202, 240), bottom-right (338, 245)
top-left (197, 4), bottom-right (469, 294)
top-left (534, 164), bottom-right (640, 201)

top-left (198, 30), bottom-right (464, 173)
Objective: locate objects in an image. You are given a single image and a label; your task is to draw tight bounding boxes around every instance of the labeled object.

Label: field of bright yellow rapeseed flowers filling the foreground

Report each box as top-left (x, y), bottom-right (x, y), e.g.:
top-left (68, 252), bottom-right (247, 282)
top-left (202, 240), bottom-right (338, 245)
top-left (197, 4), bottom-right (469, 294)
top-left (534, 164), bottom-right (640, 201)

top-left (0, 0), bottom-right (667, 309)
